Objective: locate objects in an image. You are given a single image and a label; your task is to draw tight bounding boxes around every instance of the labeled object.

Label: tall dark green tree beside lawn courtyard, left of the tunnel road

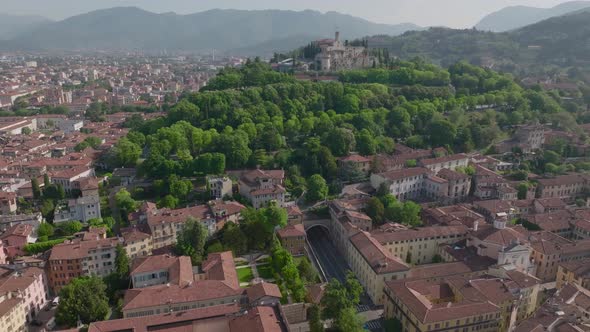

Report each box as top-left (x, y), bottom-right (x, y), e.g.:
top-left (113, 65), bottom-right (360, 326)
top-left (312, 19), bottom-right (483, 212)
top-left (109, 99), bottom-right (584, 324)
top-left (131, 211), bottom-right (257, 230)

top-left (175, 217), bottom-right (208, 265)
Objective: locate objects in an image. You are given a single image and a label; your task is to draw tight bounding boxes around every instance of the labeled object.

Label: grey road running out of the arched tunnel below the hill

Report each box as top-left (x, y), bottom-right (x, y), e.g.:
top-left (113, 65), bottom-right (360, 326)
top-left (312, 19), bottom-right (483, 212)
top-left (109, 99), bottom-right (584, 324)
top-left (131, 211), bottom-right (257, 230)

top-left (307, 227), bottom-right (350, 283)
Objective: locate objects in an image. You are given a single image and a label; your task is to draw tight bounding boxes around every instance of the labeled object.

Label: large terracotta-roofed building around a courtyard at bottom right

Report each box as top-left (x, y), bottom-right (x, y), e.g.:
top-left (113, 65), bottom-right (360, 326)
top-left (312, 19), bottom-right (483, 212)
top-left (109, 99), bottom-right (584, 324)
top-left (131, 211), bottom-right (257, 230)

top-left (384, 265), bottom-right (540, 332)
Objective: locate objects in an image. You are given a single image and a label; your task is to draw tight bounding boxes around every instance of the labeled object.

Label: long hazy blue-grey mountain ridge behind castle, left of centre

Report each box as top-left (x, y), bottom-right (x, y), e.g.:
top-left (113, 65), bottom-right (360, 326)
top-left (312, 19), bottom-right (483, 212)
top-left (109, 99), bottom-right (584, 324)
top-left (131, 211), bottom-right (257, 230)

top-left (4, 7), bottom-right (421, 51)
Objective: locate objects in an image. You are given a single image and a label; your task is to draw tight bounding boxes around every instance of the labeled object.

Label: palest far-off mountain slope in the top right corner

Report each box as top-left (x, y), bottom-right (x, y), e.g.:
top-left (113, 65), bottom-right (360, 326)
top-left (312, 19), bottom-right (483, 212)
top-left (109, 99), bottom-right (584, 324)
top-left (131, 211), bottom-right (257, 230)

top-left (475, 1), bottom-right (590, 32)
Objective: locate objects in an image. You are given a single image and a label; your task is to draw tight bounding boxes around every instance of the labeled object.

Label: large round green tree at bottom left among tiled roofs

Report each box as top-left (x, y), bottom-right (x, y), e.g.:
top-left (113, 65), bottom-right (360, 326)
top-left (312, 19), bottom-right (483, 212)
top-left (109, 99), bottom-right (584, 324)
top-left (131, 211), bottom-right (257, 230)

top-left (55, 277), bottom-right (109, 327)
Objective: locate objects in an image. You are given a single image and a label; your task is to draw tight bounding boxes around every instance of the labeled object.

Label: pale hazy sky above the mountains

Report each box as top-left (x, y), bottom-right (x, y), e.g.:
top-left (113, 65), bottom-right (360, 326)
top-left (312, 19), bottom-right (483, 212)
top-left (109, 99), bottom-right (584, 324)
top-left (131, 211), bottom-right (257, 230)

top-left (0, 0), bottom-right (580, 28)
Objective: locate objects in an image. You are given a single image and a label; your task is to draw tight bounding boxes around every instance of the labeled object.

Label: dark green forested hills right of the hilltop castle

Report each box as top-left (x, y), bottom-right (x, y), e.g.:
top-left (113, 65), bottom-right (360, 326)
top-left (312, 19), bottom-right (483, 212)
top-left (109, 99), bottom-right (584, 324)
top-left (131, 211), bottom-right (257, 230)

top-left (360, 9), bottom-right (590, 73)
